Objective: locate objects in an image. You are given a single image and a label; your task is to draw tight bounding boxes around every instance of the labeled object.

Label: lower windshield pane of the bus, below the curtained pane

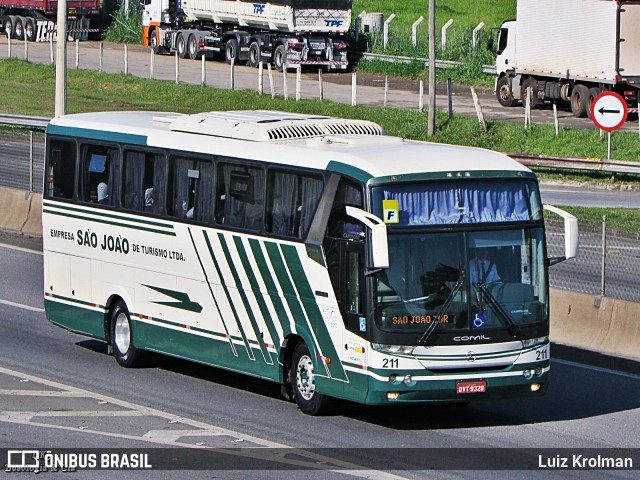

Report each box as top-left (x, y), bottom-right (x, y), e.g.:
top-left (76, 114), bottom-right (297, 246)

top-left (375, 228), bottom-right (548, 332)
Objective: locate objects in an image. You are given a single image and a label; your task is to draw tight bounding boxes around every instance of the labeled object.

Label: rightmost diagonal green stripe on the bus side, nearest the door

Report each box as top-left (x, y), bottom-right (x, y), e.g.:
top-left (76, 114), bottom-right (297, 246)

top-left (280, 245), bottom-right (347, 380)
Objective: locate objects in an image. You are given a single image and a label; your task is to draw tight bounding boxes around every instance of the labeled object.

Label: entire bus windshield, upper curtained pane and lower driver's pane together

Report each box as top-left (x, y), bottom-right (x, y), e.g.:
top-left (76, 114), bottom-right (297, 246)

top-left (372, 180), bottom-right (548, 340)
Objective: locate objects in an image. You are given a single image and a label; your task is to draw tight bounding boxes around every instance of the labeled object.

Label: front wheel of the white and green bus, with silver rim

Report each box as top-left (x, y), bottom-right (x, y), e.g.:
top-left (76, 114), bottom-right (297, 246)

top-left (290, 342), bottom-right (330, 415)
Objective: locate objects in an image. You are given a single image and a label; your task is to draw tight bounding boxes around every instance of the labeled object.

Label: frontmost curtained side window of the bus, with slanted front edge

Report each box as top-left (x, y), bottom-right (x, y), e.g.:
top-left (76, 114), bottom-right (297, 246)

top-left (266, 171), bottom-right (323, 238)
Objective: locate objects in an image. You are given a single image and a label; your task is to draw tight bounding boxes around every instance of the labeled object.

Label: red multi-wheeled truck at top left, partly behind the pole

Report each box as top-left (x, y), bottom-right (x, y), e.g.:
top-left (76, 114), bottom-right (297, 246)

top-left (0, 0), bottom-right (100, 42)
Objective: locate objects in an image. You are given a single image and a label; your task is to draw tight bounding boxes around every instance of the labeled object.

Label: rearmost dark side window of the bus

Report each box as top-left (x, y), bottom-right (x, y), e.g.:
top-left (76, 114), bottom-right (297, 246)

top-left (45, 140), bottom-right (76, 198)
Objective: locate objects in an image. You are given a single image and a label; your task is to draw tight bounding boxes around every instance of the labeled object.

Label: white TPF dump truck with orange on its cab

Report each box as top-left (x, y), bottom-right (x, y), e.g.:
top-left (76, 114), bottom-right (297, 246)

top-left (142, 0), bottom-right (352, 71)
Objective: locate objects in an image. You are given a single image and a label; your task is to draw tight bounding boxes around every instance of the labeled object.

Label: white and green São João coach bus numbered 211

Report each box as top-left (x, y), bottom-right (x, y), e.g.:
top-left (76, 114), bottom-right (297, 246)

top-left (42, 111), bottom-right (578, 415)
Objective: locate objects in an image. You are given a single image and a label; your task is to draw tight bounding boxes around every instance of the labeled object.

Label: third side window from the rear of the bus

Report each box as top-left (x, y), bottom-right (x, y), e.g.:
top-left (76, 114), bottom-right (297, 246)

top-left (122, 150), bottom-right (166, 214)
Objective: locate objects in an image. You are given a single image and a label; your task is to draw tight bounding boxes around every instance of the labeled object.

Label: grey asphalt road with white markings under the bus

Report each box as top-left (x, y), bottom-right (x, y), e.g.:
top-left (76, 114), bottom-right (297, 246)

top-left (0, 237), bottom-right (640, 479)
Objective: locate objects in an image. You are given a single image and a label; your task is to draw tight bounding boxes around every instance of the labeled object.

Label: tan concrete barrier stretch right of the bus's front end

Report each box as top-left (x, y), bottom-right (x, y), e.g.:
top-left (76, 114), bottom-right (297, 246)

top-left (551, 289), bottom-right (640, 361)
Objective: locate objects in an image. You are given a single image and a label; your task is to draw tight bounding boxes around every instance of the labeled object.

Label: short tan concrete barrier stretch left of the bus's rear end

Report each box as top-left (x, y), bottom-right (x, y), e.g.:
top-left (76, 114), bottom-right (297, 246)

top-left (0, 187), bottom-right (42, 237)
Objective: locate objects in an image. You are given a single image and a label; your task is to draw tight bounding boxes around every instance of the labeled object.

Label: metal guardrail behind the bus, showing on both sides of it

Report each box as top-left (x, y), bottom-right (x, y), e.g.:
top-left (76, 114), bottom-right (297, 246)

top-left (0, 114), bottom-right (640, 175)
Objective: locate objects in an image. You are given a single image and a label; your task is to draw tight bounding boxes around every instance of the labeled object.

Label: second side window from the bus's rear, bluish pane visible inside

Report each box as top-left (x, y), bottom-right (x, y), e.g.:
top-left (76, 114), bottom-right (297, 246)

top-left (79, 145), bottom-right (120, 205)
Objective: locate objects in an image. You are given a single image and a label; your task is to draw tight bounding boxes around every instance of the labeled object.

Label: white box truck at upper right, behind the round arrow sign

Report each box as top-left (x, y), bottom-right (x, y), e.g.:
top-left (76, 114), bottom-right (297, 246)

top-left (489, 0), bottom-right (640, 117)
